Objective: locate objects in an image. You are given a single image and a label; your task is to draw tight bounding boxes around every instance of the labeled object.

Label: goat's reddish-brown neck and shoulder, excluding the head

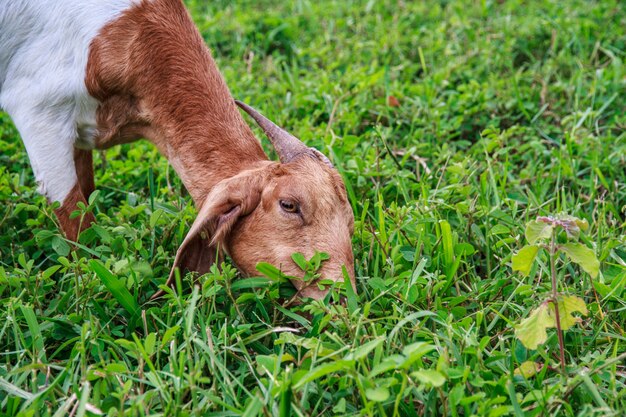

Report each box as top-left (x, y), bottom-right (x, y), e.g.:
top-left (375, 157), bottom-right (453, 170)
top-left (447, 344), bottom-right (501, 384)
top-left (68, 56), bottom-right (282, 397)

top-left (86, 0), bottom-right (267, 205)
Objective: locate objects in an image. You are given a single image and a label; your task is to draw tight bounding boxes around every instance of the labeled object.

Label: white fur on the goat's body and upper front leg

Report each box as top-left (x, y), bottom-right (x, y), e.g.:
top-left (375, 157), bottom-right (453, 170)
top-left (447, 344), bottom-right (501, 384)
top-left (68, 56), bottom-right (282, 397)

top-left (0, 0), bottom-right (139, 202)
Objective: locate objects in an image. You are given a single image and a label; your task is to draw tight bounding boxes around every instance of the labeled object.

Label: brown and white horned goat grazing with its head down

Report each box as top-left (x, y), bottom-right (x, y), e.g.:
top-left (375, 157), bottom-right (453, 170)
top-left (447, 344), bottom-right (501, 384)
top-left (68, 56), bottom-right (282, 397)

top-left (0, 0), bottom-right (354, 298)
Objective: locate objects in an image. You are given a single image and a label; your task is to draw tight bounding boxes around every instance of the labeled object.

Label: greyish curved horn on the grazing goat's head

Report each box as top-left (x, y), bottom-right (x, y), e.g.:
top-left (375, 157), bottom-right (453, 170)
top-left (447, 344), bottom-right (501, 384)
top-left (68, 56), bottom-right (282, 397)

top-left (235, 100), bottom-right (332, 168)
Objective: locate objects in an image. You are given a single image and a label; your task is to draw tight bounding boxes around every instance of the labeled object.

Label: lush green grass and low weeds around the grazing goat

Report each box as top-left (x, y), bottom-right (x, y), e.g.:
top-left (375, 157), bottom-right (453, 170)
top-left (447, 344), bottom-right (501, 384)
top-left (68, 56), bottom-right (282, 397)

top-left (0, 0), bottom-right (626, 416)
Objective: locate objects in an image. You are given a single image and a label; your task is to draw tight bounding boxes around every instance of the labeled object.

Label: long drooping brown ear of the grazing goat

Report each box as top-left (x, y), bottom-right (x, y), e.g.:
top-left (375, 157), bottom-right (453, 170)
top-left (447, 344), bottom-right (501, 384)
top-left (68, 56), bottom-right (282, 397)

top-left (152, 173), bottom-right (264, 299)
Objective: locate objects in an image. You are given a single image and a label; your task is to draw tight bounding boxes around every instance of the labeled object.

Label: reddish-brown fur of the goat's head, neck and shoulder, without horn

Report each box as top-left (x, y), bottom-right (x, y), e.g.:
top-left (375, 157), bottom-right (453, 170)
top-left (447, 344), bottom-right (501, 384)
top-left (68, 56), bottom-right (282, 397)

top-left (86, 0), bottom-right (354, 298)
